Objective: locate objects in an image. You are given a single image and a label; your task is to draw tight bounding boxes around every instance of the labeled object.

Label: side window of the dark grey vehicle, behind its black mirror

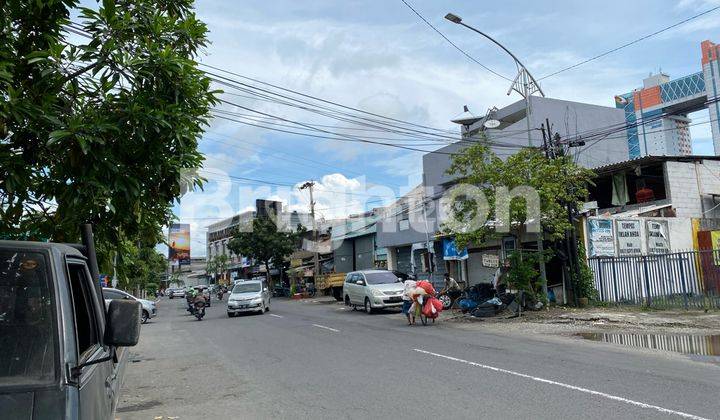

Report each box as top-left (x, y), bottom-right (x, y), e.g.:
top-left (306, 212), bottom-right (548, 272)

top-left (68, 262), bottom-right (100, 359)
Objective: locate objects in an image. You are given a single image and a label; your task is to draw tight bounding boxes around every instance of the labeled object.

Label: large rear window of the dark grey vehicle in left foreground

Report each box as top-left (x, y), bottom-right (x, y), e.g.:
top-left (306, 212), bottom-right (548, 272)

top-left (0, 249), bottom-right (58, 387)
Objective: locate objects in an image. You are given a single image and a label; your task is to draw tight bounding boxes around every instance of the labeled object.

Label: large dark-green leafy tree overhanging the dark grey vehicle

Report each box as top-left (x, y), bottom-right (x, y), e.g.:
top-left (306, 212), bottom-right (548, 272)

top-left (0, 0), bottom-right (216, 272)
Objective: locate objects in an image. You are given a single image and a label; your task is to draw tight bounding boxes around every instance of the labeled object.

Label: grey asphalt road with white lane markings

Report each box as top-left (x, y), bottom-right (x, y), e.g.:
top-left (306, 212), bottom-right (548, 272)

top-left (116, 299), bottom-right (720, 420)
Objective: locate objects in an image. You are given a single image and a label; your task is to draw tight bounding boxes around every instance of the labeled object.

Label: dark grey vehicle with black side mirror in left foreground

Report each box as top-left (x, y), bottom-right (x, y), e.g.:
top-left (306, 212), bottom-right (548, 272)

top-left (0, 238), bottom-right (140, 419)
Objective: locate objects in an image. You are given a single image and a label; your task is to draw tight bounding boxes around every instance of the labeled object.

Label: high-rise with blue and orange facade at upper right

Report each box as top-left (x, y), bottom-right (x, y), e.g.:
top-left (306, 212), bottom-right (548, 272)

top-left (615, 41), bottom-right (720, 159)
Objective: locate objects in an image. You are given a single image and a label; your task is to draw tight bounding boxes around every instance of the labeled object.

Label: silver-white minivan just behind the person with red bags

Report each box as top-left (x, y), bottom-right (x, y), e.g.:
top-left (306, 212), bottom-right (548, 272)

top-left (343, 270), bottom-right (403, 314)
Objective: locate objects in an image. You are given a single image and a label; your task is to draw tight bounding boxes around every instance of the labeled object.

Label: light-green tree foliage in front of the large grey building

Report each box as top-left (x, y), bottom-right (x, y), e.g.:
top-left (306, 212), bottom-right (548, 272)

top-left (445, 138), bottom-right (593, 247)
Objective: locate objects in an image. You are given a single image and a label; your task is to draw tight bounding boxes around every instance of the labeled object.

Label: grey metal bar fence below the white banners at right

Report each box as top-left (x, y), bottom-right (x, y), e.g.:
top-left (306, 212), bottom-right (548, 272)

top-left (588, 249), bottom-right (720, 309)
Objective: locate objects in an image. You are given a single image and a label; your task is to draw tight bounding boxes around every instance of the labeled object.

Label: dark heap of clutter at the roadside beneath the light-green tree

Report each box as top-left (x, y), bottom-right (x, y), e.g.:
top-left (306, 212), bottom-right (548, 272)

top-left (457, 283), bottom-right (542, 318)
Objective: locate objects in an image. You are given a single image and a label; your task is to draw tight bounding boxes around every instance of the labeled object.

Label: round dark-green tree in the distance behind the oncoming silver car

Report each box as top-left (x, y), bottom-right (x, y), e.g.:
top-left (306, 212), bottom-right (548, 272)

top-left (228, 217), bottom-right (304, 284)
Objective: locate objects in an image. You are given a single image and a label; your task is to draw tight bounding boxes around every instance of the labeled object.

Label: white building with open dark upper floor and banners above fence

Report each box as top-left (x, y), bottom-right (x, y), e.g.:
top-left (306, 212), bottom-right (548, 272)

top-left (583, 156), bottom-right (720, 257)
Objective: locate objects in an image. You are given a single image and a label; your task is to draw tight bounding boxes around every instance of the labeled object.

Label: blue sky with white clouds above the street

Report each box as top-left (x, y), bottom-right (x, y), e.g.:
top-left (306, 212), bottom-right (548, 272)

top-left (142, 0), bottom-right (720, 257)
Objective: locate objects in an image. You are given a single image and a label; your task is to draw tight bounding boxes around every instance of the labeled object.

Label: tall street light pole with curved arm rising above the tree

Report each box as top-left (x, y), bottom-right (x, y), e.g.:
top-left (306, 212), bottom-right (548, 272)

top-left (445, 13), bottom-right (547, 302)
